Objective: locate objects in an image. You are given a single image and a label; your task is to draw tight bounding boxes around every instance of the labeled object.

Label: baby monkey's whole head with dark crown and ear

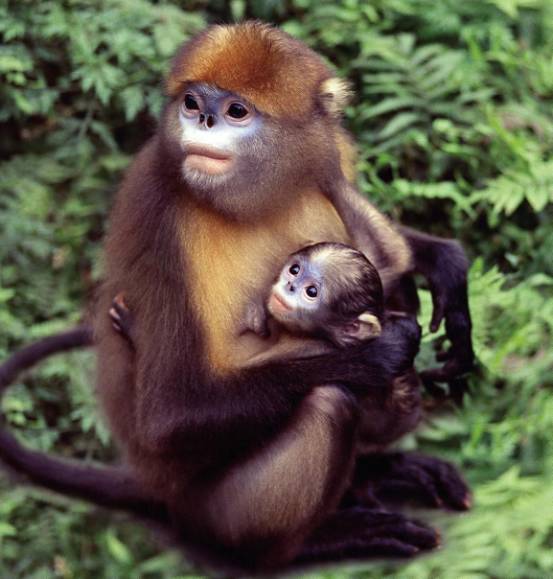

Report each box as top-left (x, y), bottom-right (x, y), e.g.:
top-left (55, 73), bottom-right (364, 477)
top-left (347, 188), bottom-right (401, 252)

top-left (267, 243), bottom-right (384, 347)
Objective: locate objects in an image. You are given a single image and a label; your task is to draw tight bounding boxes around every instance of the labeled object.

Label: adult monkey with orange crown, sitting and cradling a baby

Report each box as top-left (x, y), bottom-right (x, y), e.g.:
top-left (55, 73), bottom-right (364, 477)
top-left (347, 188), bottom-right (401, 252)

top-left (0, 23), bottom-right (470, 569)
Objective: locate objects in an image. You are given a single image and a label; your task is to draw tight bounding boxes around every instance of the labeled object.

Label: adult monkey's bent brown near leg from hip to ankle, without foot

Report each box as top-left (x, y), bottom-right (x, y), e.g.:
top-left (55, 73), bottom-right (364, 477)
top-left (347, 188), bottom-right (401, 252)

top-left (179, 386), bottom-right (357, 570)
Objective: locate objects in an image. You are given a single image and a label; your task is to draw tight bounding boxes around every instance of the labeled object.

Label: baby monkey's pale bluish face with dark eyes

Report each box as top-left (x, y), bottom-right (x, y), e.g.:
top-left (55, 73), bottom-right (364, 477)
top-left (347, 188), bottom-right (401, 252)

top-left (267, 255), bottom-right (327, 331)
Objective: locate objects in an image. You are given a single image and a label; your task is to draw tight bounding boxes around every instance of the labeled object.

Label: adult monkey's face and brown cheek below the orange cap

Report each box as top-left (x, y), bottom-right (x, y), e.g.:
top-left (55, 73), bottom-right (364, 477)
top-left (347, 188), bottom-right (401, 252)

top-left (172, 83), bottom-right (312, 220)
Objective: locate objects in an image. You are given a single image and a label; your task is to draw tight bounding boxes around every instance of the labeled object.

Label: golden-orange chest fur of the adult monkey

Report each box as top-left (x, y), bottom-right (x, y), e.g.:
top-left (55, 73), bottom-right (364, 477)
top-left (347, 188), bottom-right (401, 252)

top-left (182, 189), bottom-right (350, 372)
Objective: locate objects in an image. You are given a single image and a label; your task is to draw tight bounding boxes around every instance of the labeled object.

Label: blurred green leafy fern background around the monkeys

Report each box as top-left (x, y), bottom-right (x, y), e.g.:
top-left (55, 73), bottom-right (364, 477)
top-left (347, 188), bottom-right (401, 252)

top-left (0, 0), bottom-right (553, 579)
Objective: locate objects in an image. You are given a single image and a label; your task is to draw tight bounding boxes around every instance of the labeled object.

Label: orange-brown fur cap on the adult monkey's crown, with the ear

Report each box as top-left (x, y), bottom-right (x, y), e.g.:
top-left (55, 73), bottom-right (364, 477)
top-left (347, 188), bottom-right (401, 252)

top-left (167, 22), bottom-right (342, 119)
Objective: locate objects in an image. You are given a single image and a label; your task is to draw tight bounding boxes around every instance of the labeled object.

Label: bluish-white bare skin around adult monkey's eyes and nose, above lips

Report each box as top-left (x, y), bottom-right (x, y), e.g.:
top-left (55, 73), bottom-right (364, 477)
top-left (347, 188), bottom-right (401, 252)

top-left (179, 84), bottom-right (262, 154)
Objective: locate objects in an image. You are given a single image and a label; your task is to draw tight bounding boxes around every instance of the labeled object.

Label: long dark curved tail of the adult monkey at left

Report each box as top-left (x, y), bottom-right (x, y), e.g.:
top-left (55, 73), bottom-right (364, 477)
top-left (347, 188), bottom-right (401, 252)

top-left (0, 325), bottom-right (167, 522)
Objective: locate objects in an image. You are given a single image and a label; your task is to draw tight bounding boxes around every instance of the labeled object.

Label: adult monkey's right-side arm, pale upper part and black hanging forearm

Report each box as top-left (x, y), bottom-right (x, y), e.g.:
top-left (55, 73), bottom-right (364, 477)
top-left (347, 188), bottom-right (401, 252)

top-left (322, 175), bottom-right (474, 386)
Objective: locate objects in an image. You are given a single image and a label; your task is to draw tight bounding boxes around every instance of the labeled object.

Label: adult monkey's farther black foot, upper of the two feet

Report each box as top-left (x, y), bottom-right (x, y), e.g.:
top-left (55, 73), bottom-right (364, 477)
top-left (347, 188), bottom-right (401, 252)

top-left (351, 452), bottom-right (472, 511)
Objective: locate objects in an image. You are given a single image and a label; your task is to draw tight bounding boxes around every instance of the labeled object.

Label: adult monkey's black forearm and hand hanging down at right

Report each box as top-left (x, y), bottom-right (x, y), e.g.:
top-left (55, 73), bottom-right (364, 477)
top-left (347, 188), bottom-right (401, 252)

top-left (400, 227), bottom-right (474, 394)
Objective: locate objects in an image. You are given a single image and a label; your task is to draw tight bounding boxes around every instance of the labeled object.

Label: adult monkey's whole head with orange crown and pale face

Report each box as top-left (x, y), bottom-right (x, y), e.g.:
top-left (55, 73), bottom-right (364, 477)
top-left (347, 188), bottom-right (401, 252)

top-left (160, 23), bottom-right (350, 221)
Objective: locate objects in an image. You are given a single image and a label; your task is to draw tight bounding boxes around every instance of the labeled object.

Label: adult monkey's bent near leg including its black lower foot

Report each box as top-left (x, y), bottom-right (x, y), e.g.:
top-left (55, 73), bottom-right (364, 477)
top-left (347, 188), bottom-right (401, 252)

top-left (175, 386), bottom-right (437, 570)
